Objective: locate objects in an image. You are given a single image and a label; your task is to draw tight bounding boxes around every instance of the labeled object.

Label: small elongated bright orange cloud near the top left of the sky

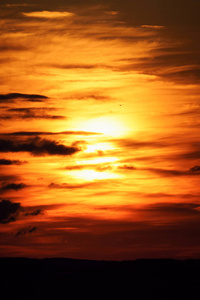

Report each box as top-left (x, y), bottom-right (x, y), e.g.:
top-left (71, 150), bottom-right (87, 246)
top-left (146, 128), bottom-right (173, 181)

top-left (22, 10), bottom-right (75, 19)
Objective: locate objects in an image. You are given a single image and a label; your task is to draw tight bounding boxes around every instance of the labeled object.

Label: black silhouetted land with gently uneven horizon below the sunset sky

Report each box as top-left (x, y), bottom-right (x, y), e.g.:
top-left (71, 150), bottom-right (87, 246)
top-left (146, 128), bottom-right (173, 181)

top-left (0, 258), bottom-right (200, 300)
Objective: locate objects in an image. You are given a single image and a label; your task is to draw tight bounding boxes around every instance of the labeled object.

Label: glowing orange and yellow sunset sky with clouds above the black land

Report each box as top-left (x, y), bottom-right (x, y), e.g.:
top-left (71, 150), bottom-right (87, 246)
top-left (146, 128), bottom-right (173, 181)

top-left (0, 0), bottom-right (200, 260)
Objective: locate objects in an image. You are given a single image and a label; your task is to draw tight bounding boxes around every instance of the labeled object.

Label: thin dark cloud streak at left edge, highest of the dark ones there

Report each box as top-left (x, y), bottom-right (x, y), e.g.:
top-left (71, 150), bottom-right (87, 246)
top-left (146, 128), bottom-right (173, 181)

top-left (0, 93), bottom-right (48, 103)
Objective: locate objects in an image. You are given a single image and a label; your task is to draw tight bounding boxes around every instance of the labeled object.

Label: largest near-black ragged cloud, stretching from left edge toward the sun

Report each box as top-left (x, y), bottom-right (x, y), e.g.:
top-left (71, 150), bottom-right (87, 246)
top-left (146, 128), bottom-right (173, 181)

top-left (0, 137), bottom-right (80, 156)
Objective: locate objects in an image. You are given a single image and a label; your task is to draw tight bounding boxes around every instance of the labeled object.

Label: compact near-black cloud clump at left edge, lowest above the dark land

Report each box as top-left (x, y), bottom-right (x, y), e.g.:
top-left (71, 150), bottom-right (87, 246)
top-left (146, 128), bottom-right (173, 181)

top-left (0, 200), bottom-right (21, 224)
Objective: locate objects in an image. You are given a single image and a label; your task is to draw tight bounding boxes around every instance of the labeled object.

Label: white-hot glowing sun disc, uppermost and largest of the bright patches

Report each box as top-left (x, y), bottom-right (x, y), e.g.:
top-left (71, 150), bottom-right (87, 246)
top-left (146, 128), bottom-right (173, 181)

top-left (82, 117), bottom-right (125, 136)
